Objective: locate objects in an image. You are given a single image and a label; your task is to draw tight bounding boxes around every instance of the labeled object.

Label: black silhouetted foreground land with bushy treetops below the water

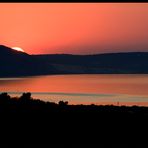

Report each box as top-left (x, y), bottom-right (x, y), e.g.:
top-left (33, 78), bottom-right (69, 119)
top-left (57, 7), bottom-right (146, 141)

top-left (0, 93), bottom-right (148, 147)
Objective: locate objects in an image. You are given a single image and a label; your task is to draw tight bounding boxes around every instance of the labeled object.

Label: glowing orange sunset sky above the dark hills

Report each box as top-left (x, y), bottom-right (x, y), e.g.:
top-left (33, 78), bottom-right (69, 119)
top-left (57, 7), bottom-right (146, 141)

top-left (0, 3), bottom-right (148, 54)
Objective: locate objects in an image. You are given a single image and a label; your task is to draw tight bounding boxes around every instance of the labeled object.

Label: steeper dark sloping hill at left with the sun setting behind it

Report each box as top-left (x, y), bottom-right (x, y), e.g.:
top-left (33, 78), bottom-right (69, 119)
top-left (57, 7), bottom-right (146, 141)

top-left (0, 45), bottom-right (56, 77)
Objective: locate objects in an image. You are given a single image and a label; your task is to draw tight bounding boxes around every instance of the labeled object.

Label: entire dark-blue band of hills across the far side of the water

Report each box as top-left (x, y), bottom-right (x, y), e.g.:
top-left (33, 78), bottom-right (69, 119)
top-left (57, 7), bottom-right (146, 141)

top-left (0, 45), bottom-right (148, 77)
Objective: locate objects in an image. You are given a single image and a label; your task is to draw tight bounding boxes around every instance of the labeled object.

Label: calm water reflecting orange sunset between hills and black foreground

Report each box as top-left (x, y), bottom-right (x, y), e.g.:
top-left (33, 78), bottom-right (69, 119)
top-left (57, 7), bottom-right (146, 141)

top-left (0, 74), bottom-right (148, 106)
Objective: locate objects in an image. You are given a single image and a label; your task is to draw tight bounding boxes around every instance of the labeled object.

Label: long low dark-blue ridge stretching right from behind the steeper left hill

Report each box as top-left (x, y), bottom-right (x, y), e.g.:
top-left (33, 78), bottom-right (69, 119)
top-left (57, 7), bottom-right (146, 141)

top-left (35, 52), bottom-right (148, 74)
